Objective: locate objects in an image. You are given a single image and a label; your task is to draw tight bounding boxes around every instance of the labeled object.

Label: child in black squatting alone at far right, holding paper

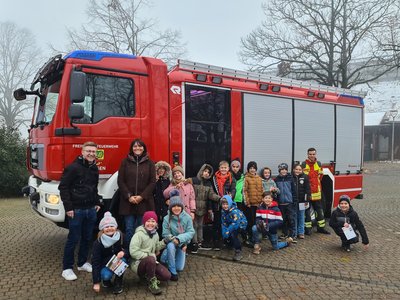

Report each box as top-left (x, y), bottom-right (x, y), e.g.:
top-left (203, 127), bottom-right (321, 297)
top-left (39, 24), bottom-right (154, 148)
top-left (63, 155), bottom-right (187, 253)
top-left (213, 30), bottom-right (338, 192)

top-left (329, 195), bottom-right (369, 252)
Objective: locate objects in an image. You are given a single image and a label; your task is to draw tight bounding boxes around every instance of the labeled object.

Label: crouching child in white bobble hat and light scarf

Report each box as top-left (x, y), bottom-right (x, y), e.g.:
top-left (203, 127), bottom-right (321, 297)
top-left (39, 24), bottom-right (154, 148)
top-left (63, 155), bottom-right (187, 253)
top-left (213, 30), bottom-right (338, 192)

top-left (92, 211), bottom-right (125, 294)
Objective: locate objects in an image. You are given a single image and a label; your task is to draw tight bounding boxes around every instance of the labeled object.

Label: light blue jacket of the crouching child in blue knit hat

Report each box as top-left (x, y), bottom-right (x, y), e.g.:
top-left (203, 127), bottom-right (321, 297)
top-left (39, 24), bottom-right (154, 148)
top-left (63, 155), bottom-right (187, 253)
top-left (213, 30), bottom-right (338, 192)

top-left (162, 209), bottom-right (194, 247)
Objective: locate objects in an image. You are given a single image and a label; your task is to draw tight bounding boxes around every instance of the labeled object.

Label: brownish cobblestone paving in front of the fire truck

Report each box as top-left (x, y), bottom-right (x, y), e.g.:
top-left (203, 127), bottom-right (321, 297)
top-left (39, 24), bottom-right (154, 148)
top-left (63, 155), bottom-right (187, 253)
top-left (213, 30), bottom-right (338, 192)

top-left (0, 163), bottom-right (400, 299)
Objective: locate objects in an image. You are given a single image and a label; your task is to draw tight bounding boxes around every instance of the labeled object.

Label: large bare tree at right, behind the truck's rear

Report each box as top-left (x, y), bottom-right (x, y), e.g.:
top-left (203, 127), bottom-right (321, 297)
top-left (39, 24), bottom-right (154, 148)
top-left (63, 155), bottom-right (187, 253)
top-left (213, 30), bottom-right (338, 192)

top-left (240, 0), bottom-right (396, 88)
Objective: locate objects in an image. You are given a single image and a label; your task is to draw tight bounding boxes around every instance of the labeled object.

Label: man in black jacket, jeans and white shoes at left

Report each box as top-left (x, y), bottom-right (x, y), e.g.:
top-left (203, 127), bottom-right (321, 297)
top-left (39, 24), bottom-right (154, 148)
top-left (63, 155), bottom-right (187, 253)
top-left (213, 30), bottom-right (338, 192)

top-left (58, 142), bottom-right (100, 280)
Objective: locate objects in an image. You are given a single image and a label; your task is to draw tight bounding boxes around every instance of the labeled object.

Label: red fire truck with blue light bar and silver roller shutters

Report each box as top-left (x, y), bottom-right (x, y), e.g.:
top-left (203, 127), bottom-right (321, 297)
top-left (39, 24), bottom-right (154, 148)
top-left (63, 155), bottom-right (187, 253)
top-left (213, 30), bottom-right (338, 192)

top-left (14, 51), bottom-right (365, 224)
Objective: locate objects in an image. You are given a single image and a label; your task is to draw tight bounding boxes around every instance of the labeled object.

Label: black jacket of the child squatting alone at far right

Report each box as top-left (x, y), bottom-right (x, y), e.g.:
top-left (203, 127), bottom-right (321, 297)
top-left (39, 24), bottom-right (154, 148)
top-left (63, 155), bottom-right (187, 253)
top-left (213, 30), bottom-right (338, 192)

top-left (329, 205), bottom-right (369, 245)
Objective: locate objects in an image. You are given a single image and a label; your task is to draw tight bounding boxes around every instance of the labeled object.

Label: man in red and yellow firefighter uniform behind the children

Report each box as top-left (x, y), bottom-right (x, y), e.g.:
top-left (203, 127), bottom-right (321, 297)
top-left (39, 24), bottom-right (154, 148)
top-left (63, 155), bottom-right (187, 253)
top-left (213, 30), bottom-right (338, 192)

top-left (301, 148), bottom-right (330, 235)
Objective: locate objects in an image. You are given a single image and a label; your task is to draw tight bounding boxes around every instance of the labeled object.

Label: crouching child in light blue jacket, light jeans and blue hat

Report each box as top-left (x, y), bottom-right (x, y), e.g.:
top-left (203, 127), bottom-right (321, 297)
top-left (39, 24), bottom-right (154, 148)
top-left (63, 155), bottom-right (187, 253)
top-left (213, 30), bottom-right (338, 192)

top-left (161, 191), bottom-right (194, 281)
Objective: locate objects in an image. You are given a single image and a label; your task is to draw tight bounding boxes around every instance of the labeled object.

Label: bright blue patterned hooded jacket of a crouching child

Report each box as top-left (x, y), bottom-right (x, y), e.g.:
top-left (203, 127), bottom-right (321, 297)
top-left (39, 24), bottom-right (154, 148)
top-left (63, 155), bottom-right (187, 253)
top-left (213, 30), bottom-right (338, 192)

top-left (221, 195), bottom-right (247, 239)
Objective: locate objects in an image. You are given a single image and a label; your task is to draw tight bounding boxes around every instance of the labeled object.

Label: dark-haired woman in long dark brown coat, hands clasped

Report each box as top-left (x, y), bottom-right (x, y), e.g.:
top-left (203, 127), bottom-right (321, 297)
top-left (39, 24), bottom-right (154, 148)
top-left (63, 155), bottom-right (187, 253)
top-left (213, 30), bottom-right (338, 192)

top-left (118, 139), bottom-right (156, 249)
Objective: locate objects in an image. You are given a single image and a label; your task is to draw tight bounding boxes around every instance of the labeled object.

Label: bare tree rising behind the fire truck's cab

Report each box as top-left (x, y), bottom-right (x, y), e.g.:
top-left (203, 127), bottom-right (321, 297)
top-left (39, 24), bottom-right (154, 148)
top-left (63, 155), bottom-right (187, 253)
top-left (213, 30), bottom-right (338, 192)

top-left (68, 0), bottom-right (185, 64)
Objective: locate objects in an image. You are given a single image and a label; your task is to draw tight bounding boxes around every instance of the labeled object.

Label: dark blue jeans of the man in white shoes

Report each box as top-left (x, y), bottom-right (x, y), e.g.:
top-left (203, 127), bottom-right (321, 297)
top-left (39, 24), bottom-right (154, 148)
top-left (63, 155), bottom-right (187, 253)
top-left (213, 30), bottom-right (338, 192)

top-left (63, 207), bottom-right (97, 270)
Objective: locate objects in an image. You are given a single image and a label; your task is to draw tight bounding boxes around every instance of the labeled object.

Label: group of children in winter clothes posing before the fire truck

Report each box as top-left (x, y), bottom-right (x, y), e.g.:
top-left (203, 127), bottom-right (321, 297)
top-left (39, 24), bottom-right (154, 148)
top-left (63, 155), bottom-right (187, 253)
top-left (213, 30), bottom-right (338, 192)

top-left (92, 159), bottom-right (369, 294)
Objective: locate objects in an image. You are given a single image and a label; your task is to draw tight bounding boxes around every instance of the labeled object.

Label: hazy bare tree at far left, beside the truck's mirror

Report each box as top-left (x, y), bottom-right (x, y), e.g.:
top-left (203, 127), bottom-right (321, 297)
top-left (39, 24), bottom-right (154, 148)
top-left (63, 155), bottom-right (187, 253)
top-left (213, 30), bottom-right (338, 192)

top-left (0, 22), bottom-right (40, 130)
